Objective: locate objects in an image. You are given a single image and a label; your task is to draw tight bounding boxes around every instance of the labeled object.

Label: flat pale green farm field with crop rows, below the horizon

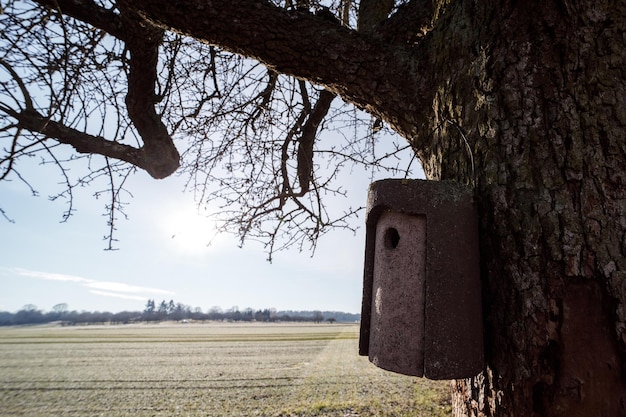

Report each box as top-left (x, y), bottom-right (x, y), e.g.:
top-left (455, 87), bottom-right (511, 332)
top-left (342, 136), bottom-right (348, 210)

top-left (0, 323), bottom-right (450, 417)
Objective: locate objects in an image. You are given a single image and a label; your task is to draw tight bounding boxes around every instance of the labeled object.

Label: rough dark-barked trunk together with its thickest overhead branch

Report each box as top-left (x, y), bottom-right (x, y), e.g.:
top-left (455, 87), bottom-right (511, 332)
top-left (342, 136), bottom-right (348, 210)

top-left (4, 0), bottom-right (626, 416)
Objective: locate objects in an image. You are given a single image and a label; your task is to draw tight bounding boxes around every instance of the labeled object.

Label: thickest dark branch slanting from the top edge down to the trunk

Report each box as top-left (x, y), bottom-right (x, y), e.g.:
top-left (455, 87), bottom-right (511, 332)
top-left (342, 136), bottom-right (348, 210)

top-left (123, 0), bottom-right (436, 137)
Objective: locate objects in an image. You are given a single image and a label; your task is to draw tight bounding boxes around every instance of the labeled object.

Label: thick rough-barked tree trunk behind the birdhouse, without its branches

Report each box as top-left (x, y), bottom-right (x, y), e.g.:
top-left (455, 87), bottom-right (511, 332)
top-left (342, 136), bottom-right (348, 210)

top-left (414, 1), bottom-right (626, 416)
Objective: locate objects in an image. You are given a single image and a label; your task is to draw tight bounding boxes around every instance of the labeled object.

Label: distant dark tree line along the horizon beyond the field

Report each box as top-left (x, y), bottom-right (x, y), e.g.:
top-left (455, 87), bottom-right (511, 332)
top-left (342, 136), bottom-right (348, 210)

top-left (0, 299), bottom-right (361, 326)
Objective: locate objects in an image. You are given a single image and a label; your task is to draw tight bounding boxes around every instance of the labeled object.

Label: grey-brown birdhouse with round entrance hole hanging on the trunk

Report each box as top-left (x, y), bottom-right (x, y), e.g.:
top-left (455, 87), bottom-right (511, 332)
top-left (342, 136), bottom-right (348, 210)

top-left (359, 180), bottom-right (484, 379)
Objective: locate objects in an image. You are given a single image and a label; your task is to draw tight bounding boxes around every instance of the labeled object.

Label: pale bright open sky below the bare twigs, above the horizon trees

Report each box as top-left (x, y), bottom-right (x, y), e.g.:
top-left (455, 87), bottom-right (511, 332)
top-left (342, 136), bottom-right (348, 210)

top-left (0, 132), bottom-right (421, 313)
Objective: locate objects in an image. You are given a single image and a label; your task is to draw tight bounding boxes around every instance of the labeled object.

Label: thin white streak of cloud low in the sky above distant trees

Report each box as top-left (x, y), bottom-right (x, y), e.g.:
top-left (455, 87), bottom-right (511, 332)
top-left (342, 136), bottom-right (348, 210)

top-left (13, 268), bottom-right (175, 301)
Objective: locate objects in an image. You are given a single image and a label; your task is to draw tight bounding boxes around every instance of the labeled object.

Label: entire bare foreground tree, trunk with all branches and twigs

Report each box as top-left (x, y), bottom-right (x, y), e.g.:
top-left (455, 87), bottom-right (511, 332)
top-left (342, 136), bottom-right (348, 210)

top-left (0, 0), bottom-right (626, 416)
